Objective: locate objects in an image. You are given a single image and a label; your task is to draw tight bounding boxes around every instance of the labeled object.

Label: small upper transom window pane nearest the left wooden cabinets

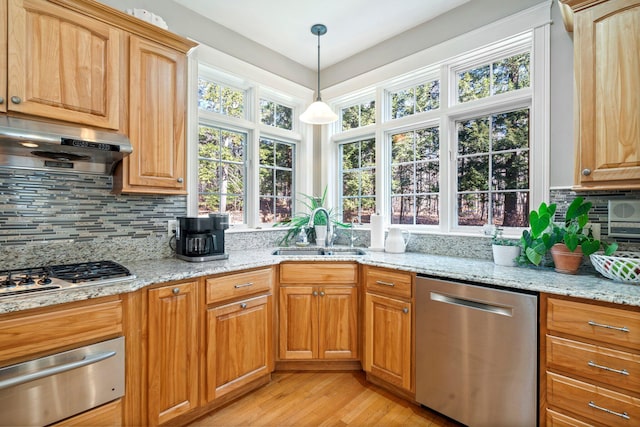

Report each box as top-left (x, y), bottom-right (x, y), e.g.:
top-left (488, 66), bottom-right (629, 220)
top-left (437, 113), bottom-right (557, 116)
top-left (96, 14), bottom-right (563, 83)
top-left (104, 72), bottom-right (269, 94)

top-left (198, 77), bottom-right (245, 118)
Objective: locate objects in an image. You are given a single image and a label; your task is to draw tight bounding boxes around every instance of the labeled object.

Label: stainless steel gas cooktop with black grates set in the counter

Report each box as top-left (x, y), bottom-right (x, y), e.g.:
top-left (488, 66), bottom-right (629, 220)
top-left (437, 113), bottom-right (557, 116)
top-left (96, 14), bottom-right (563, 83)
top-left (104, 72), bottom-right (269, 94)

top-left (0, 261), bottom-right (135, 298)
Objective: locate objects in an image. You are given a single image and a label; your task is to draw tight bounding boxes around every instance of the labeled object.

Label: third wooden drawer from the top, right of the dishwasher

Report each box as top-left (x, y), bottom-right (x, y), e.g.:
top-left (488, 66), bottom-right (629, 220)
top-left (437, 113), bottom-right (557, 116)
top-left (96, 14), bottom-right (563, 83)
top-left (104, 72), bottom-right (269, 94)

top-left (547, 372), bottom-right (640, 426)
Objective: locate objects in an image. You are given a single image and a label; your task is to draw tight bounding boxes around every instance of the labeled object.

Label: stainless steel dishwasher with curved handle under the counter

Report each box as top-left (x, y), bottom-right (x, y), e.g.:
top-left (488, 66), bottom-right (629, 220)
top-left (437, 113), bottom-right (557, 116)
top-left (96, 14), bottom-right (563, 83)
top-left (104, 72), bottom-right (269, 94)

top-left (416, 277), bottom-right (538, 427)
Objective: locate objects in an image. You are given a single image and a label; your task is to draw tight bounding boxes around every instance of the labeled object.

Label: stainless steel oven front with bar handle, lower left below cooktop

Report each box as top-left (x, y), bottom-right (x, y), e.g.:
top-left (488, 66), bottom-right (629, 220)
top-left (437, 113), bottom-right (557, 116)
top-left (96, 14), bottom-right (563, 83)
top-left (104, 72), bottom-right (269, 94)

top-left (0, 337), bottom-right (124, 426)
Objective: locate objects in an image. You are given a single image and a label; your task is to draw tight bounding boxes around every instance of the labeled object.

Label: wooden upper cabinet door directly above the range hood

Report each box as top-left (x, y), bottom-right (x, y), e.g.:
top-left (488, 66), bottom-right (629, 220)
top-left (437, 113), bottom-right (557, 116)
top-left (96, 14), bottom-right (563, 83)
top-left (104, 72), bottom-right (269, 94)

top-left (3, 0), bottom-right (122, 129)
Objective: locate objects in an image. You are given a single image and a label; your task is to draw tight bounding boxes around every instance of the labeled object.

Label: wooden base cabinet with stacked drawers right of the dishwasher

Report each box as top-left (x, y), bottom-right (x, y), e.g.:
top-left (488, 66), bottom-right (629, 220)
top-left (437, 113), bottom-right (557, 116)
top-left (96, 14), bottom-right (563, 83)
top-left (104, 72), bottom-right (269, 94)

top-left (540, 295), bottom-right (640, 426)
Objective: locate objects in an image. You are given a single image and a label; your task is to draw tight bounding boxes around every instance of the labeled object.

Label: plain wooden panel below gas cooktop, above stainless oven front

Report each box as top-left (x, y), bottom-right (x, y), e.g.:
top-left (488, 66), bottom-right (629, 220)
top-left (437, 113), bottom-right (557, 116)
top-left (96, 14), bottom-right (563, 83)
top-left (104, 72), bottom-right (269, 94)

top-left (0, 300), bottom-right (122, 362)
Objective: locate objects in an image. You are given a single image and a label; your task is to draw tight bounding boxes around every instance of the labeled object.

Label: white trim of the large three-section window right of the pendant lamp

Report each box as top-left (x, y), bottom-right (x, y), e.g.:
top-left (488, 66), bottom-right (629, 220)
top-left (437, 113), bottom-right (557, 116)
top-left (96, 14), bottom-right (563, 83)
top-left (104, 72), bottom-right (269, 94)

top-left (321, 1), bottom-right (552, 236)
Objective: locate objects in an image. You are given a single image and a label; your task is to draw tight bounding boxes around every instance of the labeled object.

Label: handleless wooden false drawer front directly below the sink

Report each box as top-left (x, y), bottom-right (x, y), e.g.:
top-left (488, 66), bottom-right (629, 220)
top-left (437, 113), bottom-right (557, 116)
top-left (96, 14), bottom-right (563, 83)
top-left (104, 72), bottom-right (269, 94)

top-left (280, 262), bottom-right (358, 285)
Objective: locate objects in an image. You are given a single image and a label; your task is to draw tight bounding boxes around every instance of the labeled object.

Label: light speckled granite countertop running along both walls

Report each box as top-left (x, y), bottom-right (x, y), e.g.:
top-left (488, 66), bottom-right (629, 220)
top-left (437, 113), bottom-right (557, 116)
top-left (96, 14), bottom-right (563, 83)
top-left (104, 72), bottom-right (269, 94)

top-left (0, 248), bottom-right (640, 314)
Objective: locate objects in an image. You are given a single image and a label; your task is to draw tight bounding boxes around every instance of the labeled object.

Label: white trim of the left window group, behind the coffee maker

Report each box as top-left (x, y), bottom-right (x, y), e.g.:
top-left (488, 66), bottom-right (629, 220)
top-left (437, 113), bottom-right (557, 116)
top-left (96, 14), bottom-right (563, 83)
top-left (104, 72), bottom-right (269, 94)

top-left (187, 44), bottom-right (314, 232)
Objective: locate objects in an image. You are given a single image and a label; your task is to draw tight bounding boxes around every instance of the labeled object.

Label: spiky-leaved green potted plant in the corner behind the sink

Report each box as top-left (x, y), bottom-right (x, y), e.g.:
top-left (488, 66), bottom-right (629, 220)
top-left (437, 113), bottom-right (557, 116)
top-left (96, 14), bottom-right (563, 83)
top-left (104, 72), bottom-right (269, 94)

top-left (273, 187), bottom-right (349, 246)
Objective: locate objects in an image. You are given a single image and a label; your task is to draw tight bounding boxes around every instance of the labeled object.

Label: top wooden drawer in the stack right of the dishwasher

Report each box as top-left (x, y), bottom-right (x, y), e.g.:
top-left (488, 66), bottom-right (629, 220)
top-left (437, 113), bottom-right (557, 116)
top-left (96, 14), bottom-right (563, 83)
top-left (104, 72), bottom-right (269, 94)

top-left (547, 298), bottom-right (640, 349)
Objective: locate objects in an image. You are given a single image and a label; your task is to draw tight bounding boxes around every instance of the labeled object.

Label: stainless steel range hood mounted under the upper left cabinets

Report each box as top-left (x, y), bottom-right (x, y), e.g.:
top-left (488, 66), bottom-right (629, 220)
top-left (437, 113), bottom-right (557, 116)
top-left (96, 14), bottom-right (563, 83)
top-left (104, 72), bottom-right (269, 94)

top-left (0, 115), bottom-right (133, 175)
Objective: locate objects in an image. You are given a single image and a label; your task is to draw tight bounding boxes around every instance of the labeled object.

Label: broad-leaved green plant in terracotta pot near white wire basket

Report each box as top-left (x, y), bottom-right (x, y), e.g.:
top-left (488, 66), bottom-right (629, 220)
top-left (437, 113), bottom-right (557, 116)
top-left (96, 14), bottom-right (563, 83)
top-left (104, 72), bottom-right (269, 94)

top-left (520, 197), bottom-right (618, 274)
